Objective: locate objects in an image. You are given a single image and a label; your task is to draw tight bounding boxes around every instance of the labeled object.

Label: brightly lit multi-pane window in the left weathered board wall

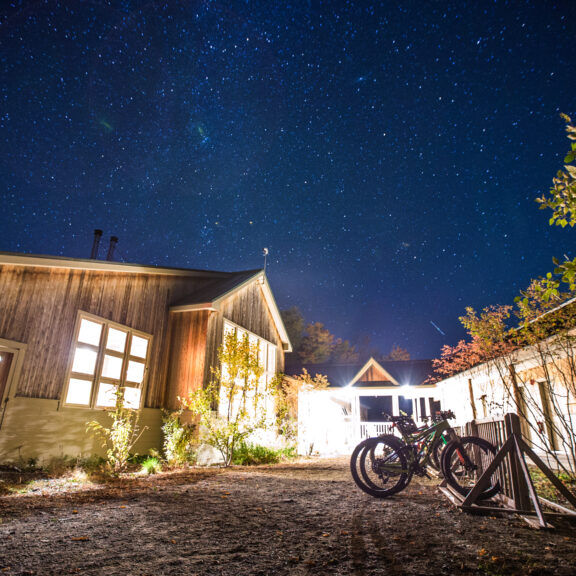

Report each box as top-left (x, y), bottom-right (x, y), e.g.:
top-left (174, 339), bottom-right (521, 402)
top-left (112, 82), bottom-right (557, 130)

top-left (64, 316), bottom-right (150, 408)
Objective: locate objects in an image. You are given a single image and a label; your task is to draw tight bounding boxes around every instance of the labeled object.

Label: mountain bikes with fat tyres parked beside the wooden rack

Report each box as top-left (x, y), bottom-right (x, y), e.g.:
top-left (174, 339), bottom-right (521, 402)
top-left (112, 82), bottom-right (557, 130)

top-left (350, 412), bottom-right (500, 499)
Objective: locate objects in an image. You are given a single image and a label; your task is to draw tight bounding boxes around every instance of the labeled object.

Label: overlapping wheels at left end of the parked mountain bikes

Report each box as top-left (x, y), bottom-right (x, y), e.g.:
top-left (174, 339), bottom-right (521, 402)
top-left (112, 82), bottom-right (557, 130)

top-left (350, 436), bottom-right (410, 498)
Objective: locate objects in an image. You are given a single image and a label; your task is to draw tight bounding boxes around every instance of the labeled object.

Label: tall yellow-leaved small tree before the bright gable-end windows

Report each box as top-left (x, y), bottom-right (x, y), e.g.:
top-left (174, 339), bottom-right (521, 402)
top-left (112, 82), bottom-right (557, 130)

top-left (184, 332), bottom-right (271, 466)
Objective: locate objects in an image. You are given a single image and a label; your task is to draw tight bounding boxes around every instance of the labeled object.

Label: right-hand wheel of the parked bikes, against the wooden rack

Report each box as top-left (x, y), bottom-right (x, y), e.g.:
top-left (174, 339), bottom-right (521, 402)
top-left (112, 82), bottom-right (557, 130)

top-left (441, 436), bottom-right (501, 500)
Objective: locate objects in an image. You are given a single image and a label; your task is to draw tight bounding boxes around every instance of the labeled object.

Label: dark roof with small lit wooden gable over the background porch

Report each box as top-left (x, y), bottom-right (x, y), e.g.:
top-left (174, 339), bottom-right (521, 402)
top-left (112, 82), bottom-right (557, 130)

top-left (286, 358), bottom-right (432, 388)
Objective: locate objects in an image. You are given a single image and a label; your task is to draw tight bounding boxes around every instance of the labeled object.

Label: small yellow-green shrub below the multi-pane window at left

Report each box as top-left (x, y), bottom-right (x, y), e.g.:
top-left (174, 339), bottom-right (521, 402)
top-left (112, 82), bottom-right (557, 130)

top-left (87, 388), bottom-right (148, 474)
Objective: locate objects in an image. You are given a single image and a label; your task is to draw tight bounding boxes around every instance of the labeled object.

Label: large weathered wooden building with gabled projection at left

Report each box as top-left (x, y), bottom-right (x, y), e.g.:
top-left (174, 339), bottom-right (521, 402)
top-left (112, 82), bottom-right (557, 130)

top-left (0, 253), bottom-right (291, 462)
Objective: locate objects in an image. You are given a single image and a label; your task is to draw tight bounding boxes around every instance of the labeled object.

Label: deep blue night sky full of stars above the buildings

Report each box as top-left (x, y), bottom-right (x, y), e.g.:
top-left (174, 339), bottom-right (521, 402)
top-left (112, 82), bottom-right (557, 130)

top-left (0, 0), bottom-right (576, 358)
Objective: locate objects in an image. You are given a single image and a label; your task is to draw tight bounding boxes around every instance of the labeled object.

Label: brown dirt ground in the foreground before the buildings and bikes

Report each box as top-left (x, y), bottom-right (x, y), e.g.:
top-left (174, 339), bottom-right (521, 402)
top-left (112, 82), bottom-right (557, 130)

top-left (0, 459), bottom-right (576, 576)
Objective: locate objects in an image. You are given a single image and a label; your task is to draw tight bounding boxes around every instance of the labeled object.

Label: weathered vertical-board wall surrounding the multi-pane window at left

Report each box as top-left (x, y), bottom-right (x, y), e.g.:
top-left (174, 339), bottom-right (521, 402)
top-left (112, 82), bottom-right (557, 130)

top-left (0, 265), bottom-right (212, 408)
